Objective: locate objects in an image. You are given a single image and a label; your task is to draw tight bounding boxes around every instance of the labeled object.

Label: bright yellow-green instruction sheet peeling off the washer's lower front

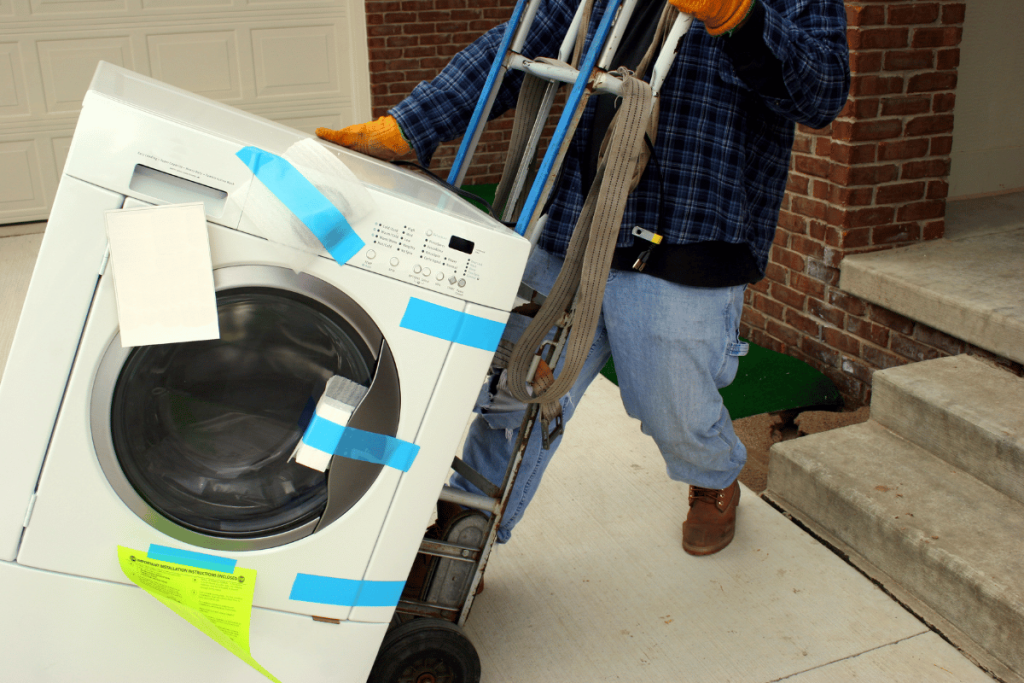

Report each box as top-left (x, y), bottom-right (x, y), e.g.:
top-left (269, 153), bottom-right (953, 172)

top-left (118, 546), bottom-right (281, 683)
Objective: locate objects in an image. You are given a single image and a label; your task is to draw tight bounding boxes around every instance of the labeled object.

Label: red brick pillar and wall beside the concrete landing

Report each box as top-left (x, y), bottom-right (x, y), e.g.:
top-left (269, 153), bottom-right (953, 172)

top-left (741, 0), bottom-right (1020, 404)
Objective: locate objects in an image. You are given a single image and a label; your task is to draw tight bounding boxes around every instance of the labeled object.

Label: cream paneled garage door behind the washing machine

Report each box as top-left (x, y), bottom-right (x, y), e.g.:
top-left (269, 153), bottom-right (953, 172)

top-left (0, 0), bottom-right (371, 225)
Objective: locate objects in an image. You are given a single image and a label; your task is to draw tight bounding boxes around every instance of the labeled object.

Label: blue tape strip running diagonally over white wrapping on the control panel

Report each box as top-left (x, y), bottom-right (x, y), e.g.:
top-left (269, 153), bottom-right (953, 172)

top-left (236, 146), bottom-right (366, 263)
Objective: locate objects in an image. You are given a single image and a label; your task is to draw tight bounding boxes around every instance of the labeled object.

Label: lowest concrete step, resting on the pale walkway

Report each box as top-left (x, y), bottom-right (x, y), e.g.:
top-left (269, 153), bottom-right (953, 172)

top-left (765, 420), bottom-right (1024, 680)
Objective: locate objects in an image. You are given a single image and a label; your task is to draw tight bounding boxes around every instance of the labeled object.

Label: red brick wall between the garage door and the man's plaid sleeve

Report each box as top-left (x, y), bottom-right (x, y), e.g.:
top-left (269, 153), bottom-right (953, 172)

top-left (366, 0), bottom-right (515, 185)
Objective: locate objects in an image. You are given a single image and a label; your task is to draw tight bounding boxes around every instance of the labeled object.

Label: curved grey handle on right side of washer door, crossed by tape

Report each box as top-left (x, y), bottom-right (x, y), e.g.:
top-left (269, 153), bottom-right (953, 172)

top-left (313, 340), bottom-right (401, 533)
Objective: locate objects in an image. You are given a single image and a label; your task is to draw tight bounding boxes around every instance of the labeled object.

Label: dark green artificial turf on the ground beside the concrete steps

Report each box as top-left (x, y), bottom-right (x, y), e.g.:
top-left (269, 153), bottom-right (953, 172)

top-left (601, 339), bottom-right (843, 420)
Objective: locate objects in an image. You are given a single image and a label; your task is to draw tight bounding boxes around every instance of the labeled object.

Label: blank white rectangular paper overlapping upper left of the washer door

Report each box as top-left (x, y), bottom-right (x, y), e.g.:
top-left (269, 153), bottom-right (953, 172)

top-left (105, 202), bottom-right (220, 348)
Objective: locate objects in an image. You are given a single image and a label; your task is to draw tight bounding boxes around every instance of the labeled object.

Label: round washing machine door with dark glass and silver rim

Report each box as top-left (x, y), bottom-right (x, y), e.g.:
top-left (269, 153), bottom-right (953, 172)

top-left (91, 266), bottom-right (401, 550)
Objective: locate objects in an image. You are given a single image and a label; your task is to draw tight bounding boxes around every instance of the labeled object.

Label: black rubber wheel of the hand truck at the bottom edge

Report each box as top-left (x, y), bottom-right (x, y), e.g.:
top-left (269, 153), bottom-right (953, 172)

top-left (368, 618), bottom-right (480, 683)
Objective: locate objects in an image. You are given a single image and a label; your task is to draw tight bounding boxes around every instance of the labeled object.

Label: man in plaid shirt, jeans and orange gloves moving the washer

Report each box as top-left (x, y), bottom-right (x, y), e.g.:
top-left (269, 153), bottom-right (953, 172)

top-left (316, 0), bottom-right (850, 555)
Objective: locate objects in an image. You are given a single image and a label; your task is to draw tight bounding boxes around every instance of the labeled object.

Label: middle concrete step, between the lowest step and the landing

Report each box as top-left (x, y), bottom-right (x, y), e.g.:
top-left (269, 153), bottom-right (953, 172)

top-left (871, 355), bottom-right (1024, 503)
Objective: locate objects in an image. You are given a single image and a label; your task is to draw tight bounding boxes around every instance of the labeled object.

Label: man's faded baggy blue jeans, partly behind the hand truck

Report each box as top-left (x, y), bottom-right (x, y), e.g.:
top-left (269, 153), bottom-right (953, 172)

top-left (452, 249), bottom-right (748, 543)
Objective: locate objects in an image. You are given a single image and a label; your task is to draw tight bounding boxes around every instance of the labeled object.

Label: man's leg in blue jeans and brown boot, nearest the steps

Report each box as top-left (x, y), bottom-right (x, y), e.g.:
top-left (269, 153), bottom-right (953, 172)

top-left (603, 271), bottom-right (746, 555)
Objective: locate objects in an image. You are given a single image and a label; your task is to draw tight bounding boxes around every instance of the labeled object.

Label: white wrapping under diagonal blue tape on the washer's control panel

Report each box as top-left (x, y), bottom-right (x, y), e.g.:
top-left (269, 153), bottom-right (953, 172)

top-left (239, 138), bottom-right (376, 272)
